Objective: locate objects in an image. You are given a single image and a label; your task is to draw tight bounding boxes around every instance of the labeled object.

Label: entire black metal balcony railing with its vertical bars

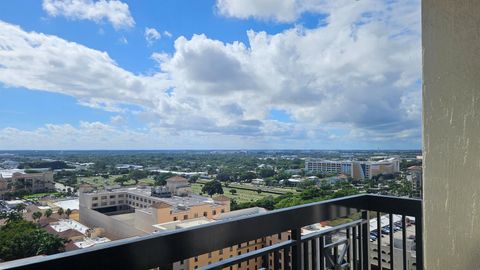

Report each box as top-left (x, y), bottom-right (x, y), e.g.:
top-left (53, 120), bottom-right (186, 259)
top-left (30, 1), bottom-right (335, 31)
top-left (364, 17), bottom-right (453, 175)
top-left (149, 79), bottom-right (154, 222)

top-left (0, 194), bottom-right (423, 270)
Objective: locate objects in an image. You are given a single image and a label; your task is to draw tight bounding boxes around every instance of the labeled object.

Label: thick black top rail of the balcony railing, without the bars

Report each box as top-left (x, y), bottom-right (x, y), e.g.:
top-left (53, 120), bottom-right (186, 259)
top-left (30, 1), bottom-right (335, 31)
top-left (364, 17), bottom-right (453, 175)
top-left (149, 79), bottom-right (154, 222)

top-left (0, 194), bottom-right (421, 269)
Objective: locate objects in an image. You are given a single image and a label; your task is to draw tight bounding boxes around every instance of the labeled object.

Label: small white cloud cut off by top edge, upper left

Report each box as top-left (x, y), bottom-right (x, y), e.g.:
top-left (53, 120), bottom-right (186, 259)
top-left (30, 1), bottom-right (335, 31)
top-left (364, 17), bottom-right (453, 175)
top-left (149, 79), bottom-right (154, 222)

top-left (42, 0), bottom-right (135, 29)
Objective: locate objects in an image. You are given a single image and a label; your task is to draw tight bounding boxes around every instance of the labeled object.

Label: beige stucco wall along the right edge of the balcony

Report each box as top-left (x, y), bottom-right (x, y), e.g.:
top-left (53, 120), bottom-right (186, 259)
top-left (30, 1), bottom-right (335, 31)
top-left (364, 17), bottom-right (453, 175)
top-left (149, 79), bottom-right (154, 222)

top-left (422, 0), bottom-right (480, 270)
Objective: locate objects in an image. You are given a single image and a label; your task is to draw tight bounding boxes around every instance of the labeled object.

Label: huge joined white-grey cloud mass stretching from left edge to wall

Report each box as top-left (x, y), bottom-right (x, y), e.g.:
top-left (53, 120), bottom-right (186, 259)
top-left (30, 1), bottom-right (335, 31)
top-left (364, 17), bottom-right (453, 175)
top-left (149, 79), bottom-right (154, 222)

top-left (0, 0), bottom-right (421, 148)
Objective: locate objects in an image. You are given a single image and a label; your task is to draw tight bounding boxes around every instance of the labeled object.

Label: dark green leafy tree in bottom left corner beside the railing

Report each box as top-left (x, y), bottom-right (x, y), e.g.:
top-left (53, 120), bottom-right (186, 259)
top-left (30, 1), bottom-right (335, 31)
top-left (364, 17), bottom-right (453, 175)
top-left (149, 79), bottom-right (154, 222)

top-left (0, 219), bottom-right (66, 261)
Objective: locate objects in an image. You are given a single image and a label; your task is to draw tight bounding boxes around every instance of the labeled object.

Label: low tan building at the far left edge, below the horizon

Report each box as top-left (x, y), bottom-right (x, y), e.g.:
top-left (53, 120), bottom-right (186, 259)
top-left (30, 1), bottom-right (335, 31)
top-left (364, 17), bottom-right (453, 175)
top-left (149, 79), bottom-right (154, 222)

top-left (0, 169), bottom-right (55, 196)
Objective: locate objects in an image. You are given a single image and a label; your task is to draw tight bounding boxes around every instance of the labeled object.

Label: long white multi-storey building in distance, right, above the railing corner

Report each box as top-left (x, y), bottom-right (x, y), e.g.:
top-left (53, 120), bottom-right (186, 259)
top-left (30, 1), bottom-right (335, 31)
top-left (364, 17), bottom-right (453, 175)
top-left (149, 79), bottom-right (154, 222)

top-left (305, 157), bottom-right (400, 180)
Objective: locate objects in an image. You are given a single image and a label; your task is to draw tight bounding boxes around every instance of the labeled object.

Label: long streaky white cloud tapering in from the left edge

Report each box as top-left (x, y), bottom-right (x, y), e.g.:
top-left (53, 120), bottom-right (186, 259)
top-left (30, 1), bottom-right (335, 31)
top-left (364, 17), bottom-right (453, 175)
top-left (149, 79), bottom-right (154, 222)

top-left (0, 21), bottom-right (169, 110)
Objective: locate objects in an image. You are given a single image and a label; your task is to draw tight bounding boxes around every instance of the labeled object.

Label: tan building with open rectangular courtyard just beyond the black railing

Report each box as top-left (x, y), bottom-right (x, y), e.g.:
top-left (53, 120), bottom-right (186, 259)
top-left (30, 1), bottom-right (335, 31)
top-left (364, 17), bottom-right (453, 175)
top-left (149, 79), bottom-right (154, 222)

top-left (79, 177), bottom-right (230, 239)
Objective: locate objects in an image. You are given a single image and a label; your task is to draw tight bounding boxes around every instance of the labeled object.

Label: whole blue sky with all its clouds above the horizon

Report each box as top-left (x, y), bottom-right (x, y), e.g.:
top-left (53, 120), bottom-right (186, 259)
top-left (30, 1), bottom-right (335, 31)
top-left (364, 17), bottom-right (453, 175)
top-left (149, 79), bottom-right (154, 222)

top-left (0, 0), bottom-right (421, 150)
